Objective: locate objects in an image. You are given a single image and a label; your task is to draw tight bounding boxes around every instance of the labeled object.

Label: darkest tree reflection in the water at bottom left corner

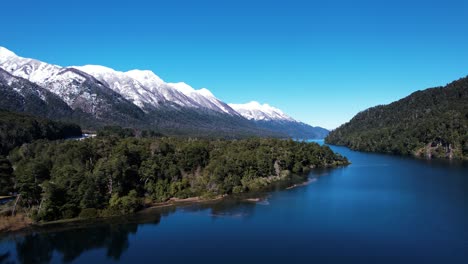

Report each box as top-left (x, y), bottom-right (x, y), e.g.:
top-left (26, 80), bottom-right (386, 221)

top-left (11, 208), bottom-right (171, 263)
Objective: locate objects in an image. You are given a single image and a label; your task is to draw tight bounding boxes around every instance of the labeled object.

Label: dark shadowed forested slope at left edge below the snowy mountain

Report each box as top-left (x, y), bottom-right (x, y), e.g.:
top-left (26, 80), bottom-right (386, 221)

top-left (0, 110), bottom-right (81, 155)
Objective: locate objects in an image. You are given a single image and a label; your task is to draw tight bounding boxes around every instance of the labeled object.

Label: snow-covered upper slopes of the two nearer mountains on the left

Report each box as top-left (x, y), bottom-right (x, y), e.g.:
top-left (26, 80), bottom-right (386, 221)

top-left (0, 47), bottom-right (238, 116)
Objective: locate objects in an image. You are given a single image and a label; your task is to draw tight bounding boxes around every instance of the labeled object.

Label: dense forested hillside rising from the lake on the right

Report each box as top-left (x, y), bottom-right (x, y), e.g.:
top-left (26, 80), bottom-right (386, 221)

top-left (326, 78), bottom-right (468, 159)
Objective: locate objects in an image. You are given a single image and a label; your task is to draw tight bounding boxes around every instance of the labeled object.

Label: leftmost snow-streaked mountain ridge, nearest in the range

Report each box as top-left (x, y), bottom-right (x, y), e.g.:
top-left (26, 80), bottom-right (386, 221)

top-left (0, 47), bottom-right (142, 119)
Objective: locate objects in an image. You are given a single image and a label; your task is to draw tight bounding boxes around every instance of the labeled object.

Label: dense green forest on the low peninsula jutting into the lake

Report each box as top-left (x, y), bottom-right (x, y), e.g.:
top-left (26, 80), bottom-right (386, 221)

top-left (6, 136), bottom-right (348, 221)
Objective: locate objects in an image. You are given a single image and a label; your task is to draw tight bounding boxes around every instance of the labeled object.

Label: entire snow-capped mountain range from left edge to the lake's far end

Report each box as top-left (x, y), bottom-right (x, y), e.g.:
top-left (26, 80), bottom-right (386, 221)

top-left (0, 47), bottom-right (328, 138)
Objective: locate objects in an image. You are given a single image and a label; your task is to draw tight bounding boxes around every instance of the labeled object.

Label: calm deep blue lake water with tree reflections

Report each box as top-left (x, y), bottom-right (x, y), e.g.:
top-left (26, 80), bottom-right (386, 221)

top-left (0, 143), bottom-right (468, 263)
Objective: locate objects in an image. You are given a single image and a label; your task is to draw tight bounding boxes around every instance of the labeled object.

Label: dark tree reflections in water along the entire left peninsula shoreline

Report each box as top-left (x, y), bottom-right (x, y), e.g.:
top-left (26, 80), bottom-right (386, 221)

top-left (0, 197), bottom-right (267, 264)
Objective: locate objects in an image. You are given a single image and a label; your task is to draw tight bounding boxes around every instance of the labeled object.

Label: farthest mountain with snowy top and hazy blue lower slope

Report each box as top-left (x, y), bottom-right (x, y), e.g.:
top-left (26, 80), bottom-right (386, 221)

top-left (229, 101), bottom-right (329, 139)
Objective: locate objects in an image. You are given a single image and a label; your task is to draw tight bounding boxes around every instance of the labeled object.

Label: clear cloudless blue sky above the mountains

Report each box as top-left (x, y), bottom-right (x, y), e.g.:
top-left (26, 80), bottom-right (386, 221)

top-left (0, 0), bottom-right (468, 128)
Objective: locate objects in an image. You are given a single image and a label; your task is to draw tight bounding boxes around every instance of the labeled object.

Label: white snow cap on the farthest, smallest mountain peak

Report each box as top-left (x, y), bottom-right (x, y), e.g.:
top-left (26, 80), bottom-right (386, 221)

top-left (229, 101), bottom-right (296, 121)
